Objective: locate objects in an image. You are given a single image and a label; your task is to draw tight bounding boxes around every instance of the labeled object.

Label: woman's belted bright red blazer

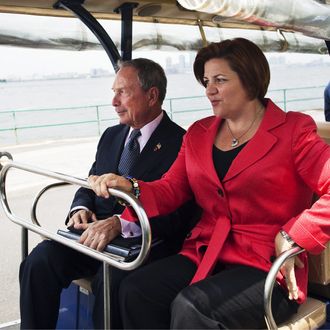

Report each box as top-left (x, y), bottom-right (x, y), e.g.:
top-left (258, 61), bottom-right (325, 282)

top-left (123, 100), bottom-right (330, 302)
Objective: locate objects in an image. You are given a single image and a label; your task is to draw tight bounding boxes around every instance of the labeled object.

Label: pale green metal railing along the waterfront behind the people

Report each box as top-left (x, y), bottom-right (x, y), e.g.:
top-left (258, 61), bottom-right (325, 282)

top-left (0, 86), bottom-right (325, 144)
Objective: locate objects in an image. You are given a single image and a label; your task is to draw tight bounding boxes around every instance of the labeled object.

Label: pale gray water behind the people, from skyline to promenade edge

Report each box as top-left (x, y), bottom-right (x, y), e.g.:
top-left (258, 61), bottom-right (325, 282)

top-left (0, 59), bottom-right (330, 145)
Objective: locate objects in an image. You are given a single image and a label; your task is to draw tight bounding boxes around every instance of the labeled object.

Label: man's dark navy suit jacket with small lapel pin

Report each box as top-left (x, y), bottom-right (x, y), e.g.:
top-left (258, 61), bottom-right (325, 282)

top-left (71, 112), bottom-right (197, 253)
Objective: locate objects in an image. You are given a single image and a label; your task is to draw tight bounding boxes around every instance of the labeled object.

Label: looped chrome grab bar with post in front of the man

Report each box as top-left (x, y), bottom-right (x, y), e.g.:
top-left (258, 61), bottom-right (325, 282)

top-left (0, 157), bottom-right (151, 329)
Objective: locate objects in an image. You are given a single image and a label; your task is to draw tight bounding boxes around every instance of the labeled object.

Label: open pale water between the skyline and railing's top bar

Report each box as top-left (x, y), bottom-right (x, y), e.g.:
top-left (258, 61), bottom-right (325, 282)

top-left (0, 60), bottom-right (330, 111)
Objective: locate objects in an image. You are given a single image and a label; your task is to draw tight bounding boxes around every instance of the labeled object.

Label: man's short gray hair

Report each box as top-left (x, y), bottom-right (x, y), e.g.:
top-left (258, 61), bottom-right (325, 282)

top-left (118, 58), bottom-right (167, 104)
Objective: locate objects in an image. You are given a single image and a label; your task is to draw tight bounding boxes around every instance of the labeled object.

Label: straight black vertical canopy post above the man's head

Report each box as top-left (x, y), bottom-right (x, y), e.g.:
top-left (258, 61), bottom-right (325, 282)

top-left (114, 2), bottom-right (138, 61)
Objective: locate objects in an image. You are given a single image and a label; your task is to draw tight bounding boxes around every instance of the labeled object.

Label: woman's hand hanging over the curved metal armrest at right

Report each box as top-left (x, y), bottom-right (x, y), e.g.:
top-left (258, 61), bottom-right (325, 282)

top-left (275, 233), bottom-right (304, 300)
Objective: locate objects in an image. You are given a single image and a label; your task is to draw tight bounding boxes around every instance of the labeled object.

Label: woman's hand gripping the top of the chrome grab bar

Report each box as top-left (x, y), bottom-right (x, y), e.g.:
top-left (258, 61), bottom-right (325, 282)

top-left (88, 173), bottom-right (132, 198)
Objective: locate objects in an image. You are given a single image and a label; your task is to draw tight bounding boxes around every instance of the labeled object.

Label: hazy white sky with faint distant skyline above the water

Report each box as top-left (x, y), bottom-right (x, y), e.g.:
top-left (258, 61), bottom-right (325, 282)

top-left (0, 46), bottom-right (330, 80)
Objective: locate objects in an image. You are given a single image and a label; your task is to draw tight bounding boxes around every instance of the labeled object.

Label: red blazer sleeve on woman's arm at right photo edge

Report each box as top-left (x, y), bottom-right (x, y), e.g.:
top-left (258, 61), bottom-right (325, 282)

top-left (283, 114), bottom-right (330, 254)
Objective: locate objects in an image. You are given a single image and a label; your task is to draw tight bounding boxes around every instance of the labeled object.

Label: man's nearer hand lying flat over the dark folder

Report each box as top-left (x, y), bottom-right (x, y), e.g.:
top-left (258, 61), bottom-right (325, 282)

top-left (79, 216), bottom-right (121, 251)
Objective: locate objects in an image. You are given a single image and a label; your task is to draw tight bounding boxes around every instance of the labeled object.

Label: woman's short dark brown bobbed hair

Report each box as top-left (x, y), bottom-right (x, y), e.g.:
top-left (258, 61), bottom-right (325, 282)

top-left (194, 38), bottom-right (270, 101)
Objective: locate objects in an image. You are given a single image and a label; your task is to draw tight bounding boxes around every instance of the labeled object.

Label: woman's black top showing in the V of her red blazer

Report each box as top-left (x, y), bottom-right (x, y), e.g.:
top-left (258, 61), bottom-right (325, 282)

top-left (212, 142), bottom-right (247, 180)
